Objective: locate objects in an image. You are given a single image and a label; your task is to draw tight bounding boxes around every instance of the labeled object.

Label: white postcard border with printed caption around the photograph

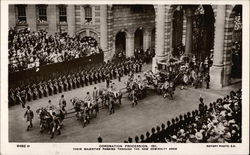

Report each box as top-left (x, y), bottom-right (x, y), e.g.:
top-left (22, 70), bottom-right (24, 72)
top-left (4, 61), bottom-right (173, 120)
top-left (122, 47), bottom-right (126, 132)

top-left (0, 0), bottom-right (249, 155)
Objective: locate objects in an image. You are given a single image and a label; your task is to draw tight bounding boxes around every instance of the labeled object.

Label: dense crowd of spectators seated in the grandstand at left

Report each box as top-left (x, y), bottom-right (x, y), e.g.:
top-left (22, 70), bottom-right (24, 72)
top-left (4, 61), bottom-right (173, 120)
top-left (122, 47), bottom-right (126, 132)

top-left (8, 28), bottom-right (102, 72)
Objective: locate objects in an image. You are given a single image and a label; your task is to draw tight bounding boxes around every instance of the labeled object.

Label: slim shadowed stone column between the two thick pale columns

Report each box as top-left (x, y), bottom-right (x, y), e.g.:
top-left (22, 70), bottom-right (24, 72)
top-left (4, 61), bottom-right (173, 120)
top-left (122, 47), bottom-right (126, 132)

top-left (185, 8), bottom-right (193, 54)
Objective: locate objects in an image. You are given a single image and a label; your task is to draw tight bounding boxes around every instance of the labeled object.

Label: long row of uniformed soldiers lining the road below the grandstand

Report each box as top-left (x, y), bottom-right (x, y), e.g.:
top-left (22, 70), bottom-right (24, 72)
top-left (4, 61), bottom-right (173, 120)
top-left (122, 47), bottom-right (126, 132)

top-left (9, 59), bottom-right (142, 108)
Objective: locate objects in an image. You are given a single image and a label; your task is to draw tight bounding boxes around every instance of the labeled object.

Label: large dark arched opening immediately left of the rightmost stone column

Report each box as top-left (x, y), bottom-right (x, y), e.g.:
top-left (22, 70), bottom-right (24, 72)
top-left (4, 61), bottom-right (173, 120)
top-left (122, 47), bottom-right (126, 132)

top-left (192, 5), bottom-right (215, 61)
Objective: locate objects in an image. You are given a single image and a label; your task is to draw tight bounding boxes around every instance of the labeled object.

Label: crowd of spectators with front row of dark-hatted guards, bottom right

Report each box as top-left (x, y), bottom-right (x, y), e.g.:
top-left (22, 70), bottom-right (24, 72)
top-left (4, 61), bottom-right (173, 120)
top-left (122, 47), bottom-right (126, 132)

top-left (124, 89), bottom-right (242, 143)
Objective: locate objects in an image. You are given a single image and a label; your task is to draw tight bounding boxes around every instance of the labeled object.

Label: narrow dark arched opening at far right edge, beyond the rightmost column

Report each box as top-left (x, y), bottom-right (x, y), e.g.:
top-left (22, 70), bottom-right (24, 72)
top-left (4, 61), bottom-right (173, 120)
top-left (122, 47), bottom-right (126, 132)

top-left (230, 5), bottom-right (242, 80)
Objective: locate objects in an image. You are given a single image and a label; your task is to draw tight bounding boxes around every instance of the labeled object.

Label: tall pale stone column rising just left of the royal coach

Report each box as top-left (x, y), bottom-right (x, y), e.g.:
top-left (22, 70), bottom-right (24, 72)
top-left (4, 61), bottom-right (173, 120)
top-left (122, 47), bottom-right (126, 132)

top-left (152, 5), bottom-right (165, 72)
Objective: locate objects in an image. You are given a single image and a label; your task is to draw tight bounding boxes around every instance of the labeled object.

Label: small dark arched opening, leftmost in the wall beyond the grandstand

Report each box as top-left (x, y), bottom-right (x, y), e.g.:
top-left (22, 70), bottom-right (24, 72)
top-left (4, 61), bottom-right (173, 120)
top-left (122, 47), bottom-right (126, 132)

top-left (115, 32), bottom-right (126, 58)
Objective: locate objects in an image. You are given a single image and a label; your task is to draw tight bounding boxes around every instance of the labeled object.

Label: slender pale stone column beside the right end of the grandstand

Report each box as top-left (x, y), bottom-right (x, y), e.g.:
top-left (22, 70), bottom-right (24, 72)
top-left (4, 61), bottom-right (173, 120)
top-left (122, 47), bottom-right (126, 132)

top-left (100, 5), bottom-right (108, 52)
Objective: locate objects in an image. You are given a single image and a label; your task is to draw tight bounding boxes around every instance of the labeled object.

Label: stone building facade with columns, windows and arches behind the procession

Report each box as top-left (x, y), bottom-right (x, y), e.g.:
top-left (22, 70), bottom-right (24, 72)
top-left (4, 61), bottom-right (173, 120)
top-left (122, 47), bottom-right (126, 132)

top-left (9, 4), bottom-right (241, 88)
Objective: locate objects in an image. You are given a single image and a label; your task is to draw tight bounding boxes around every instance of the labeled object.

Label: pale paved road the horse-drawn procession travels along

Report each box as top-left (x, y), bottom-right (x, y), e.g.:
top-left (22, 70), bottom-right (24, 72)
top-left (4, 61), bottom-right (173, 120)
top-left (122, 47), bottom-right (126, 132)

top-left (9, 65), bottom-right (241, 142)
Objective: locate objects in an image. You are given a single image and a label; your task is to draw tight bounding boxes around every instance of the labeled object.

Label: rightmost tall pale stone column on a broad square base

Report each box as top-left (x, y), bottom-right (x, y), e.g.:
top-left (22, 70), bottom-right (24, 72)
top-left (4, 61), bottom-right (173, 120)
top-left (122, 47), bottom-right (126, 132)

top-left (210, 5), bottom-right (226, 89)
